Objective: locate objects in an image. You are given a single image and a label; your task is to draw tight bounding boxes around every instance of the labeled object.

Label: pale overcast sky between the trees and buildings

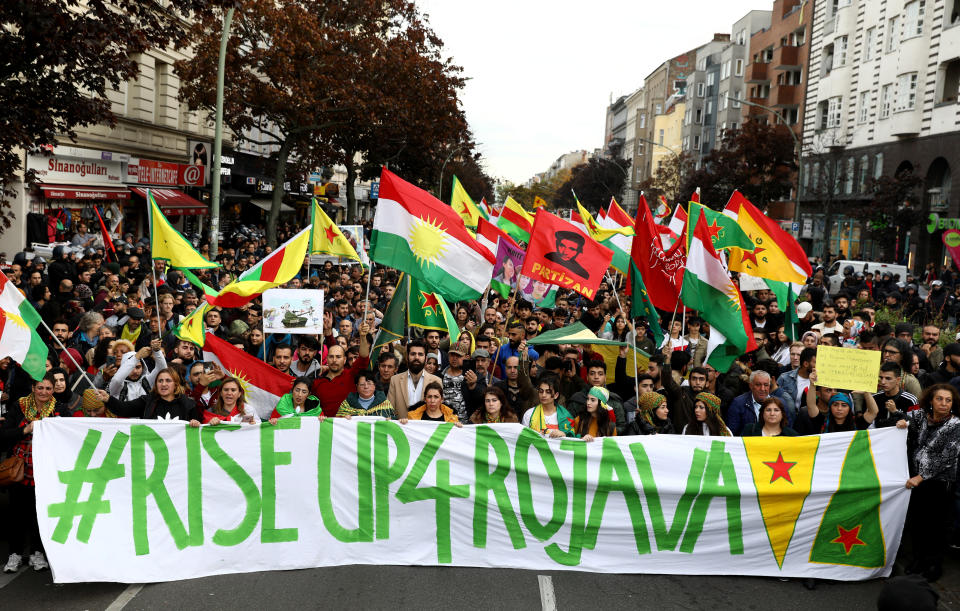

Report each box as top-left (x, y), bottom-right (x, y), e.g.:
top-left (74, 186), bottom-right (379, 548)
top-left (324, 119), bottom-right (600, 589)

top-left (416, 0), bottom-right (773, 183)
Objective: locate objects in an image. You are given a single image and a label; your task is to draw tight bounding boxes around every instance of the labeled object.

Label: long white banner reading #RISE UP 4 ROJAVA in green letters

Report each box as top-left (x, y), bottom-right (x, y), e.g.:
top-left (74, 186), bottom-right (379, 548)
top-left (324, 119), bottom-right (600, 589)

top-left (33, 418), bottom-right (909, 583)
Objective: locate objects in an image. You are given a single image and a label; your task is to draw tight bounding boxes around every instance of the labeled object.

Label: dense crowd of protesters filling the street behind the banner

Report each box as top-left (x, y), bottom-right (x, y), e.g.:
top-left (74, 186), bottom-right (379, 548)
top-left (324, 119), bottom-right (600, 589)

top-left (0, 225), bottom-right (960, 581)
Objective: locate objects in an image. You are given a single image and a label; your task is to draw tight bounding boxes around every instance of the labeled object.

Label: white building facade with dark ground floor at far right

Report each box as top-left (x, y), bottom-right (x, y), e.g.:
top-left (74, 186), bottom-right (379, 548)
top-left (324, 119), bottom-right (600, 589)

top-left (801, 0), bottom-right (960, 267)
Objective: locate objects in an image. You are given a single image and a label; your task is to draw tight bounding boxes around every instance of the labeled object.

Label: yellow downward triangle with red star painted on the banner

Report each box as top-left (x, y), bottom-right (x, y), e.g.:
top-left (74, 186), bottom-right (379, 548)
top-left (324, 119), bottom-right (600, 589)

top-left (743, 437), bottom-right (820, 568)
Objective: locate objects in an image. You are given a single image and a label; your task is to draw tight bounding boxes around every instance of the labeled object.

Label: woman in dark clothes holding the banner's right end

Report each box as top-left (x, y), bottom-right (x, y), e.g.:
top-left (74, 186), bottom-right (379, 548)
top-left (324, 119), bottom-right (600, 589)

top-left (897, 384), bottom-right (960, 581)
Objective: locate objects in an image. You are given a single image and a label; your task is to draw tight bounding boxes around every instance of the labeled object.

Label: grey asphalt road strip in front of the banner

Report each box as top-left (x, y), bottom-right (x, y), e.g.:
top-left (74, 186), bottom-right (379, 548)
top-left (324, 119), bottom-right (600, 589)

top-left (0, 566), bottom-right (908, 611)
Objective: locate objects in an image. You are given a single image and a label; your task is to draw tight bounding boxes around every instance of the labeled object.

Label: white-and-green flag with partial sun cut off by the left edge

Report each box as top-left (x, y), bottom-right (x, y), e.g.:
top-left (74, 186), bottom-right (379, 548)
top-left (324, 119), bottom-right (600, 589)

top-left (0, 272), bottom-right (48, 380)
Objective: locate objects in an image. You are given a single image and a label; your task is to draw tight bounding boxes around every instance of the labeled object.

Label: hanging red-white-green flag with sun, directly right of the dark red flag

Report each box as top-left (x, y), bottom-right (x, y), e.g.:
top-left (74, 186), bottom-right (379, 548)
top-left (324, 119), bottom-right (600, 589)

top-left (680, 210), bottom-right (757, 372)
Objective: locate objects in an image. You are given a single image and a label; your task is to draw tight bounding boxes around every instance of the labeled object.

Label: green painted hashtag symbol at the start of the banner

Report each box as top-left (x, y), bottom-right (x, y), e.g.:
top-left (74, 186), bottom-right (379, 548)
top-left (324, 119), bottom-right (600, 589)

top-left (47, 429), bottom-right (130, 543)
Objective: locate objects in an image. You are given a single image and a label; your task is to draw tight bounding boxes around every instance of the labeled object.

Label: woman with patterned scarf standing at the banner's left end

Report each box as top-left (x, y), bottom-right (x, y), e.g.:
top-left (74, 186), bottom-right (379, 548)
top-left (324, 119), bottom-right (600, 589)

top-left (0, 373), bottom-right (72, 573)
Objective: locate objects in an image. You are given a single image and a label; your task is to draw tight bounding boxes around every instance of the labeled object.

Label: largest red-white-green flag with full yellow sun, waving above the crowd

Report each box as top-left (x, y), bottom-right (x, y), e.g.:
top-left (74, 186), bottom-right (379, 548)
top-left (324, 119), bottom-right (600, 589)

top-left (370, 168), bottom-right (495, 301)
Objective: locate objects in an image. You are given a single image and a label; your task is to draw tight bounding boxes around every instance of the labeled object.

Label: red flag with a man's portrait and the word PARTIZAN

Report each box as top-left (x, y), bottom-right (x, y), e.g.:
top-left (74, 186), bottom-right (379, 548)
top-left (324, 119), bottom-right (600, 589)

top-left (521, 208), bottom-right (613, 299)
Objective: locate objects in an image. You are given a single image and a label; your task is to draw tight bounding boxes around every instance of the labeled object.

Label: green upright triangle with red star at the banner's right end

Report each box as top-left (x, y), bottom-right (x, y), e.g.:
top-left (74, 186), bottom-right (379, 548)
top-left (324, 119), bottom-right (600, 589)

top-left (810, 431), bottom-right (886, 569)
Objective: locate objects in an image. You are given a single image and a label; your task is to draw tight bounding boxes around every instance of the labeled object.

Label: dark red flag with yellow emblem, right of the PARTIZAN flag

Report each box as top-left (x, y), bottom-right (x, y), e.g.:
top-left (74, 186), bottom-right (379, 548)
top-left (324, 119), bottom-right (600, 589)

top-left (630, 195), bottom-right (687, 312)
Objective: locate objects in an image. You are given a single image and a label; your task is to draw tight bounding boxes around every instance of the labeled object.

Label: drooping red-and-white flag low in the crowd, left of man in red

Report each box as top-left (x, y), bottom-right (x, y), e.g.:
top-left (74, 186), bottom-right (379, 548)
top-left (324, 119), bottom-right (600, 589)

top-left (203, 333), bottom-right (293, 420)
